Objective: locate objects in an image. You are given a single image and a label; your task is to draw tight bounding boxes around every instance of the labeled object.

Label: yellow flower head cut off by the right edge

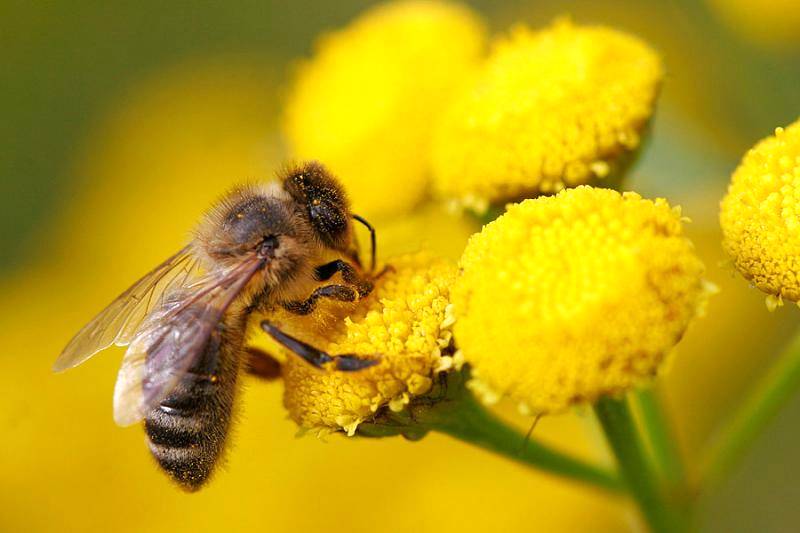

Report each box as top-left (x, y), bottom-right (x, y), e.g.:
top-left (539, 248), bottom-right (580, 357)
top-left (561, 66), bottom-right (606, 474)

top-left (720, 121), bottom-right (800, 303)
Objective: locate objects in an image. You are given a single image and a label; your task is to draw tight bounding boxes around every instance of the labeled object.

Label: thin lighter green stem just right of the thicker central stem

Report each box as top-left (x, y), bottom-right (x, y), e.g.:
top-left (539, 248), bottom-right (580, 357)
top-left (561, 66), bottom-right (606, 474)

top-left (636, 387), bottom-right (686, 497)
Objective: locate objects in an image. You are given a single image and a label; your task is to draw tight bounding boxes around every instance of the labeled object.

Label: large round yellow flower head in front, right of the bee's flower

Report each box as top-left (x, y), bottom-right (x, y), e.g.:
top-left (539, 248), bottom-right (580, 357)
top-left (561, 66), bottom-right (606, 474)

top-left (452, 186), bottom-right (705, 414)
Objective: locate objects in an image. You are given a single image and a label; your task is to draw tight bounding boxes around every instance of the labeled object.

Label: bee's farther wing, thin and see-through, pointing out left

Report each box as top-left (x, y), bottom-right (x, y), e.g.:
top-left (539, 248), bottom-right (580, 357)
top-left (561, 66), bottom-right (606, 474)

top-left (53, 246), bottom-right (196, 372)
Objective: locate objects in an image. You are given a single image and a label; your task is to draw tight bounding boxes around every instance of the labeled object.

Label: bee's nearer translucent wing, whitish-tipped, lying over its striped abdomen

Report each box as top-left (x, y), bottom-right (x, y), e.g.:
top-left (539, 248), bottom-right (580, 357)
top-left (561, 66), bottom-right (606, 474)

top-left (114, 256), bottom-right (262, 426)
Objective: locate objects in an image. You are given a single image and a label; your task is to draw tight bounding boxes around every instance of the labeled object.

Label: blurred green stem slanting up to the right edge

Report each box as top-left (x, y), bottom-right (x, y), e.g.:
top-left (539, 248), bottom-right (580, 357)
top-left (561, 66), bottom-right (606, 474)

top-left (702, 322), bottom-right (800, 490)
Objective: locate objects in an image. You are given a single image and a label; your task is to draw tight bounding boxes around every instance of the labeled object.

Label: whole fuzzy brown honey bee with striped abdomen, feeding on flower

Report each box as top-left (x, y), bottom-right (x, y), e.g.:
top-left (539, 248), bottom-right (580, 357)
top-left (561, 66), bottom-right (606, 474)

top-left (53, 162), bottom-right (377, 491)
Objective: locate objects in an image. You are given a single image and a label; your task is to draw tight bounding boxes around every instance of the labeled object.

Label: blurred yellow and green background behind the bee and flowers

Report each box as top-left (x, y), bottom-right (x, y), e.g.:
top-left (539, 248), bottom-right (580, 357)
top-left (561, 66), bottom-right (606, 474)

top-left (0, 0), bottom-right (800, 532)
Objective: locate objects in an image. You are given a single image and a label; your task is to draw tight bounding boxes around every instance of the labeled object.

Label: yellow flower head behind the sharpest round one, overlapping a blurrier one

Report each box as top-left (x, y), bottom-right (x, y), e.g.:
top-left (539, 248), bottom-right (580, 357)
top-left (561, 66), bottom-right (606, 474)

top-left (432, 20), bottom-right (663, 210)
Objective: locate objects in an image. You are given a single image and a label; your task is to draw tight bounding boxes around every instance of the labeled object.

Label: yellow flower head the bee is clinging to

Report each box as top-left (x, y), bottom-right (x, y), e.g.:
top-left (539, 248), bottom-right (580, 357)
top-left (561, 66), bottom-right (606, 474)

top-left (253, 253), bottom-right (455, 435)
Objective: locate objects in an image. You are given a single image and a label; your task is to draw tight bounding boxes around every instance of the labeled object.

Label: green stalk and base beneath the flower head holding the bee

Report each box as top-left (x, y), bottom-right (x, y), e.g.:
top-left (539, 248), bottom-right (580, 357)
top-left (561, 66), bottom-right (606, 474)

top-left (358, 370), bottom-right (623, 491)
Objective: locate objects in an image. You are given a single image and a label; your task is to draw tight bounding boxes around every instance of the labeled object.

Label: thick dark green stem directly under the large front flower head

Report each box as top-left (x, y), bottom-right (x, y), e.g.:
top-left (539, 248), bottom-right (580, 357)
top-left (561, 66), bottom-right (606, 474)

top-left (594, 398), bottom-right (687, 533)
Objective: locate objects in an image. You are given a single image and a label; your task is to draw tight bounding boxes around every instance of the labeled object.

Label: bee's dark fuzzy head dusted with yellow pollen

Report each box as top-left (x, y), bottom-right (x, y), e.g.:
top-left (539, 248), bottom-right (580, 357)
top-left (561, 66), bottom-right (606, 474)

top-left (283, 161), bottom-right (352, 251)
